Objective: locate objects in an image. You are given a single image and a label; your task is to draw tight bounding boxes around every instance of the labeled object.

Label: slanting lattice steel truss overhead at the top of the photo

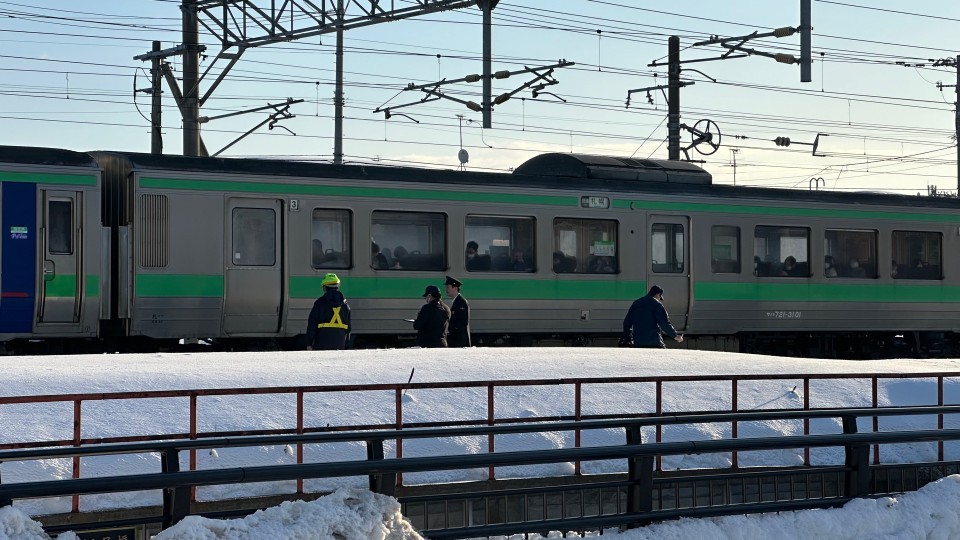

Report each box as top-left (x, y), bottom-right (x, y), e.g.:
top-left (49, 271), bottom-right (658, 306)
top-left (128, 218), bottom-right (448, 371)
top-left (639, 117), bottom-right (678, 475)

top-left (195, 0), bottom-right (477, 48)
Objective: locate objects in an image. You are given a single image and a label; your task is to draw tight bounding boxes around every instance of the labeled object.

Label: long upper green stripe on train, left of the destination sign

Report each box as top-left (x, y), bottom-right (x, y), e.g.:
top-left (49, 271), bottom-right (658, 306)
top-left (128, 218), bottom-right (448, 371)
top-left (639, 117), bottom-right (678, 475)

top-left (140, 177), bottom-right (580, 207)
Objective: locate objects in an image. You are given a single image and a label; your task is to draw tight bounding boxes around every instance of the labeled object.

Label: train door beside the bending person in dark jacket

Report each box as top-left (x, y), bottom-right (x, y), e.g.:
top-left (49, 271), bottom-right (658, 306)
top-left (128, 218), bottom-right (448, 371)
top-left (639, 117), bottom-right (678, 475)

top-left (647, 215), bottom-right (691, 330)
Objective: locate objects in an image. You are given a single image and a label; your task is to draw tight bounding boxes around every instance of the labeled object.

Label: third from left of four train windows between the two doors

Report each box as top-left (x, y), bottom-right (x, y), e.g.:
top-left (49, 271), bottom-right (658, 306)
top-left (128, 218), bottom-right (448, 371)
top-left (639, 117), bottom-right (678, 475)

top-left (464, 216), bottom-right (537, 272)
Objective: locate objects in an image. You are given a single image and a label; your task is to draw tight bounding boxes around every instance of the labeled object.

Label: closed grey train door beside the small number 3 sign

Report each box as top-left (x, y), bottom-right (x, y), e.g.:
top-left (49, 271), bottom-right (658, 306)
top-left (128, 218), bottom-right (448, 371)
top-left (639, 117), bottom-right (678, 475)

top-left (223, 198), bottom-right (283, 334)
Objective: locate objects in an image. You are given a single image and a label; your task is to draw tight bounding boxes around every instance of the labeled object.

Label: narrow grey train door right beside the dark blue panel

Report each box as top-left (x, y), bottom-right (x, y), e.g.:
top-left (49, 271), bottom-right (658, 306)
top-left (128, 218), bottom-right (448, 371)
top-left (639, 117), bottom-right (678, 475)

top-left (37, 189), bottom-right (83, 324)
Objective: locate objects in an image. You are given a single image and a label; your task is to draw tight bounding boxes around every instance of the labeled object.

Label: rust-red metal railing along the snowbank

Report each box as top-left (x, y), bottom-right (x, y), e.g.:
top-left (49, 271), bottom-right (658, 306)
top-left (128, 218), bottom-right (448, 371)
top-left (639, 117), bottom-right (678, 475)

top-left (0, 371), bottom-right (960, 512)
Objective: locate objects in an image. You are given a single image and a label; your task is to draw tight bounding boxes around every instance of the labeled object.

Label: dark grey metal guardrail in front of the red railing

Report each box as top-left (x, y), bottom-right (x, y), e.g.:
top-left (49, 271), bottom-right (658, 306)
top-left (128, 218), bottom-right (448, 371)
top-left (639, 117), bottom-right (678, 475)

top-left (0, 405), bottom-right (960, 539)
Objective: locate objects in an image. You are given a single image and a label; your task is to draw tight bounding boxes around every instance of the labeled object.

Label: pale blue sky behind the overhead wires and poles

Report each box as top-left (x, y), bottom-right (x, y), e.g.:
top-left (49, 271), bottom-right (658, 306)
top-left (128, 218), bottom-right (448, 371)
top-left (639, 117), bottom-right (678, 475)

top-left (0, 0), bottom-right (960, 194)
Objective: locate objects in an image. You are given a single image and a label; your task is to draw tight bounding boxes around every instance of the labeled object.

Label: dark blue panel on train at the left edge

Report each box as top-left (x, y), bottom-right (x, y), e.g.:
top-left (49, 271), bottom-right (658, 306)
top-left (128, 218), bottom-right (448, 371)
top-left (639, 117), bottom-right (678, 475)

top-left (0, 182), bottom-right (38, 333)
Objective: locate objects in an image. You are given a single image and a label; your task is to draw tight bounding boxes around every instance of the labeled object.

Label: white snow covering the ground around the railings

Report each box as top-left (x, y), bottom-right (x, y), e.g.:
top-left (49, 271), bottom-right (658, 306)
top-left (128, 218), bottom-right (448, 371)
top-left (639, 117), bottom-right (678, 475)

top-left (0, 348), bottom-right (960, 540)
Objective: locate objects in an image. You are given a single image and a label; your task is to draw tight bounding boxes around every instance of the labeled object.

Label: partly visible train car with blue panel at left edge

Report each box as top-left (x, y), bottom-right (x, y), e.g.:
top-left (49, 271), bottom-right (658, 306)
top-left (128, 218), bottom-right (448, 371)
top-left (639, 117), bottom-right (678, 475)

top-left (0, 146), bottom-right (107, 351)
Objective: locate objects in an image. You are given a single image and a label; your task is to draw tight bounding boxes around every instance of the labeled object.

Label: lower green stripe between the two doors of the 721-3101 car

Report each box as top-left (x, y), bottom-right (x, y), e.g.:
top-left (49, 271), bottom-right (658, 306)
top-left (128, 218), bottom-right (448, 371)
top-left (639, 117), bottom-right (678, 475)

top-left (290, 276), bottom-right (646, 300)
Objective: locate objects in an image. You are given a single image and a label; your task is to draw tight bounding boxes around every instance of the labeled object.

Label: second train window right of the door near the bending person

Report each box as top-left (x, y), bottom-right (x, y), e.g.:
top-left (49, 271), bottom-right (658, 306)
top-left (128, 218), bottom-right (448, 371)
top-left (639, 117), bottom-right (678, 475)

top-left (753, 226), bottom-right (810, 277)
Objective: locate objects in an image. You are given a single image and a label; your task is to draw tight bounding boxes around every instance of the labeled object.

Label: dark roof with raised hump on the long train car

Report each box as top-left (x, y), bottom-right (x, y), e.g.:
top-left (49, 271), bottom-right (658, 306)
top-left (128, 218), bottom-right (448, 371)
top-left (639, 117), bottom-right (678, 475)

top-left (91, 152), bottom-right (960, 215)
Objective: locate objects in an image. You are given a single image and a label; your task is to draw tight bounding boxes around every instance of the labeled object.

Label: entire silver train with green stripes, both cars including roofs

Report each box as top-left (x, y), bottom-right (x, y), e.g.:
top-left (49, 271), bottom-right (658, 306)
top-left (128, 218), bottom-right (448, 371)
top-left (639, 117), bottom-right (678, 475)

top-left (0, 147), bottom-right (960, 358)
